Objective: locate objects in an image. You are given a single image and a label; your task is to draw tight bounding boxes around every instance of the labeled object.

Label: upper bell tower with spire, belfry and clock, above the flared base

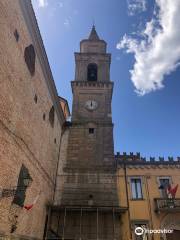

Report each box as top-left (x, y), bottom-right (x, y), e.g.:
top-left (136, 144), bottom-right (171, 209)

top-left (67, 26), bottom-right (114, 168)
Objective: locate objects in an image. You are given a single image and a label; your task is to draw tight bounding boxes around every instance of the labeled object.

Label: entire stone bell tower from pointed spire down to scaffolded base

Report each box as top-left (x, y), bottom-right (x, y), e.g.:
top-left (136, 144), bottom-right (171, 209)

top-left (52, 26), bottom-right (124, 240)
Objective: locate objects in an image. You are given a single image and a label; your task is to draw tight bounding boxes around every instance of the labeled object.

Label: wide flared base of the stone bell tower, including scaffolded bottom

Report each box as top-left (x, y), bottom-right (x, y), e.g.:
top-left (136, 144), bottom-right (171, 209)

top-left (47, 173), bottom-right (127, 240)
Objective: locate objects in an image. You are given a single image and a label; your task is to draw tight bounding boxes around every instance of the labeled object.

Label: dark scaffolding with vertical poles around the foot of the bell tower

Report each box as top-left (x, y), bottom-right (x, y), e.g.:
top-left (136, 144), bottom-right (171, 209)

top-left (45, 206), bottom-right (127, 240)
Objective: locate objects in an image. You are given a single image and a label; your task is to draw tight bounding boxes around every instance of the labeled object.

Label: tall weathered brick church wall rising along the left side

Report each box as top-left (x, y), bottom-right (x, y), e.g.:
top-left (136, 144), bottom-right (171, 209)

top-left (0, 0), bottom-right (65, 239)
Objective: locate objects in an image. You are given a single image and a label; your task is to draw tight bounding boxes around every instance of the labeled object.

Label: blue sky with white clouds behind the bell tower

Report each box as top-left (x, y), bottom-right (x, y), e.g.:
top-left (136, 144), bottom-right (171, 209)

top-left (32, 0), bottom-right (180, 158)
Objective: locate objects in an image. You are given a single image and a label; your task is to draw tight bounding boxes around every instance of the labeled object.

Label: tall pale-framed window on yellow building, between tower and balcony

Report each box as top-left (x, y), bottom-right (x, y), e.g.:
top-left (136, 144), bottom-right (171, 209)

top-left (131, 178), bottom-right (143, 199)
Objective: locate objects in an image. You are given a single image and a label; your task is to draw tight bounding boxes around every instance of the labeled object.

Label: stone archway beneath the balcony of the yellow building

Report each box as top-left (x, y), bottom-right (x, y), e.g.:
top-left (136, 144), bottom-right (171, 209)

top-left (161, 213), bottom-right (180, 240)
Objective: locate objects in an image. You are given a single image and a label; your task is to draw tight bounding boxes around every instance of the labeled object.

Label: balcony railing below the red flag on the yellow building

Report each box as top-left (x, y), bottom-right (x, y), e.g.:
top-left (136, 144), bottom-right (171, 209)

top-left (154, 198), bottom-right (180, 212)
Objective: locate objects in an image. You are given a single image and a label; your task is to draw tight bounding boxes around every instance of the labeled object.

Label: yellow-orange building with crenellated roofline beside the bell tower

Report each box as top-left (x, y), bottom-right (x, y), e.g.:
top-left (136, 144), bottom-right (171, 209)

top-left (116, 153), bottom-right (180, 240)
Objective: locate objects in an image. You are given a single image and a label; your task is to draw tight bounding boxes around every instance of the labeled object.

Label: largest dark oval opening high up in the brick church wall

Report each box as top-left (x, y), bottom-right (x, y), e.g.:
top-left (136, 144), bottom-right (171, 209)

top-left (24, 44), bottom-right (36, 76)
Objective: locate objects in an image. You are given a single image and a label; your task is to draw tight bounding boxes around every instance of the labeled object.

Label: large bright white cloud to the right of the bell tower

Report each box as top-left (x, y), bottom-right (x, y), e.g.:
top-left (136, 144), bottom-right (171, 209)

top-left (117, 0), bottom-right (180, 95)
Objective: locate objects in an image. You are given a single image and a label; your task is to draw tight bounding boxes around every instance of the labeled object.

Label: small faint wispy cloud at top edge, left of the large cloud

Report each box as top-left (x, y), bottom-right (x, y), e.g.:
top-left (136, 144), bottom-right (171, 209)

top-left (127, 0), bottom-right (146, 16)
